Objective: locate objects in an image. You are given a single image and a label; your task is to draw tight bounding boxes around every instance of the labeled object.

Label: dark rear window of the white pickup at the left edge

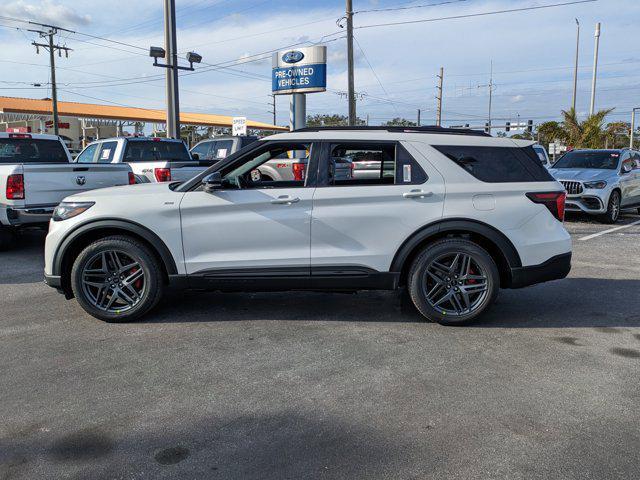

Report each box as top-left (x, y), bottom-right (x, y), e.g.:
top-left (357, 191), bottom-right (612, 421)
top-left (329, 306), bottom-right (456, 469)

top-left (0, 138), bottom-right (69, 163)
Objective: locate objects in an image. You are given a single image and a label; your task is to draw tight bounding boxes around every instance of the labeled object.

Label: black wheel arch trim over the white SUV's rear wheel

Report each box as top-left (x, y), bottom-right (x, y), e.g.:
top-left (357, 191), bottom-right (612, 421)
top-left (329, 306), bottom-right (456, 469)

top-left (390, 218), bottom-right (522, 288)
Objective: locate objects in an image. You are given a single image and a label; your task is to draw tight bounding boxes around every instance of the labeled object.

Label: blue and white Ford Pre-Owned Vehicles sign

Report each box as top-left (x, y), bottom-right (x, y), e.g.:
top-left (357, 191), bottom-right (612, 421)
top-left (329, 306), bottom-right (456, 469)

top-left (271, 46), bottom-right (327, 95)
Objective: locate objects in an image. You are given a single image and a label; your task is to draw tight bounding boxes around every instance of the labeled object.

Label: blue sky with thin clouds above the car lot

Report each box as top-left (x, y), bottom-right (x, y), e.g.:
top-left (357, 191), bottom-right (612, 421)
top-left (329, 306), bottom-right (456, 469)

top-left (0, 0), bottom-right (640, 131)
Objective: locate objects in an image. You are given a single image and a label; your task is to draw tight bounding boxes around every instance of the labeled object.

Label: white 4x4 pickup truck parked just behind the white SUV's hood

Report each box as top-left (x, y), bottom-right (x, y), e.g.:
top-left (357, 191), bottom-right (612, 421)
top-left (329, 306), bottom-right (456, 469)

top-left (75, 137), bottom-right (205, 183)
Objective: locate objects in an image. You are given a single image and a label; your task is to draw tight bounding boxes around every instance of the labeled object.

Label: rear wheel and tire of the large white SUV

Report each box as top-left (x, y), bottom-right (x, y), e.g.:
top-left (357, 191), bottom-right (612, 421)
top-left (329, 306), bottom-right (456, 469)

top-left (407, 239), bottom-right (500, 325)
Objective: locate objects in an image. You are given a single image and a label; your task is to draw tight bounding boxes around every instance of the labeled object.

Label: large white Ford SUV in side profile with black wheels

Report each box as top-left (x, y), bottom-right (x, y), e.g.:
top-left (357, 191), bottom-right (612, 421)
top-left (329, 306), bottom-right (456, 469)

top-left (45, 127), bottom-right (571, 324)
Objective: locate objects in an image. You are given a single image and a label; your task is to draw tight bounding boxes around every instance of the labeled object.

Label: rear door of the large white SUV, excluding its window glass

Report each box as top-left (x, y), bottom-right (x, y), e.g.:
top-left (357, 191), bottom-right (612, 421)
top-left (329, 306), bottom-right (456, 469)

top-left (311, 144), bottom-right (445, 272)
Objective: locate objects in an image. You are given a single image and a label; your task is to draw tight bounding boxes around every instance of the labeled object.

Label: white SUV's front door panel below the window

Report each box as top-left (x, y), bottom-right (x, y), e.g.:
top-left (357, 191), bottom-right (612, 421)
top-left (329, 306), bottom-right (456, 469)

top-left (180, 188), bottom-right (313, 274)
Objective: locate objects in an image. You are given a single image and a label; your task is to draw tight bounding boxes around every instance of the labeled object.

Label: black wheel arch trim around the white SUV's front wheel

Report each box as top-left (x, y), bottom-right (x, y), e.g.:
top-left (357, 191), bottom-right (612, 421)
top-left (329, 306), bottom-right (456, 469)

top-left (52, 219), bottom-right (178, 297)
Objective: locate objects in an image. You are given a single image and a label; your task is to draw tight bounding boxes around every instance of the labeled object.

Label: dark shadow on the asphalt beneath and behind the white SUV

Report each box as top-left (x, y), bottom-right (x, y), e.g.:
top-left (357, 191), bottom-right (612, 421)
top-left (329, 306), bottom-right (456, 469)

top-left (146, 278), bottom-right (640, 328)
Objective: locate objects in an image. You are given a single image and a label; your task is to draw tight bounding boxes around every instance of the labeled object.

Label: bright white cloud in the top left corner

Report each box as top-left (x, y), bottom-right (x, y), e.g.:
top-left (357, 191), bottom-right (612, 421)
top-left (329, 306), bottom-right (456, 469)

top-left (0, 0), bottom-right (91, 26)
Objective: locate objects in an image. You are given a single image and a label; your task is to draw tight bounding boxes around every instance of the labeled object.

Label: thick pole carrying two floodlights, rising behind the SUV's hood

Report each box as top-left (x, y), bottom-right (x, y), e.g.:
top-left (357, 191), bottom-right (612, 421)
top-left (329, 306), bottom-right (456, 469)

top-left (164, 0), bottom-right (180, 138)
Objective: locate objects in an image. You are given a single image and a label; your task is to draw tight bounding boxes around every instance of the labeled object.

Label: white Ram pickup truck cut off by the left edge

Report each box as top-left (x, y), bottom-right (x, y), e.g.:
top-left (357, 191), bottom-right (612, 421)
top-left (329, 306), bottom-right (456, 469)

top-left (0, 132), bottom-right (134, 250)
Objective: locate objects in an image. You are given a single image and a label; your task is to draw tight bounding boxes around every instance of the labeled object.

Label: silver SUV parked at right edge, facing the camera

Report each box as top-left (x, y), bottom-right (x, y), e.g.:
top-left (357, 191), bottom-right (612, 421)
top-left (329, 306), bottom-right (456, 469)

top-left (549, 149), bottom-right (640, 223)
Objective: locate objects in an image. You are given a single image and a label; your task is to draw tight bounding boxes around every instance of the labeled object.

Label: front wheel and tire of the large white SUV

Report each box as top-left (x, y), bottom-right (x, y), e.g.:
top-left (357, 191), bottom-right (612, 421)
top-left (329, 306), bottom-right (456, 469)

top-left (71, 236), bottom-right (164, 323)
